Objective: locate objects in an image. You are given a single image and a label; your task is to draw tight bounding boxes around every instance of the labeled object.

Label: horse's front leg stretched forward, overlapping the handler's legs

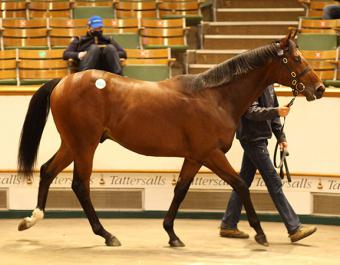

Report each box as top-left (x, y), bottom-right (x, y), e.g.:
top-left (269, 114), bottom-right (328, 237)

top-left (204, 150), bottom-right (268, 246)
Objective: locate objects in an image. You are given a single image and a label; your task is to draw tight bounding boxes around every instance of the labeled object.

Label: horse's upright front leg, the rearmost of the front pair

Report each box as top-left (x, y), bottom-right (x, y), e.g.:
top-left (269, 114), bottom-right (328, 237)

top-left (163, 159), bottom-right (202, 247)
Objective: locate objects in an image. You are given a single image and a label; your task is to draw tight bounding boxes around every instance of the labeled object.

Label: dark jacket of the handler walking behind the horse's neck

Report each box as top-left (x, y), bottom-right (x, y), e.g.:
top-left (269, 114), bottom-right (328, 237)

top-left (236, 86), bottom-right (286, 142)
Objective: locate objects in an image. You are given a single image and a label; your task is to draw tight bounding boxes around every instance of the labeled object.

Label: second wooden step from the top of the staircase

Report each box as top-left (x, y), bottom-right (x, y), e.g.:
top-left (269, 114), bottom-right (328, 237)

top-left (216, 8), bottom-right (305, 21)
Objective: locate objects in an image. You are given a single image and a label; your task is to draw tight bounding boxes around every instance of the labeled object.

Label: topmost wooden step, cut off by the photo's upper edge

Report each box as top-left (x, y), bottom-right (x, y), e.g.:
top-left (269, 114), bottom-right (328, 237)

top-left (217, 0), bottom-right (301, 8)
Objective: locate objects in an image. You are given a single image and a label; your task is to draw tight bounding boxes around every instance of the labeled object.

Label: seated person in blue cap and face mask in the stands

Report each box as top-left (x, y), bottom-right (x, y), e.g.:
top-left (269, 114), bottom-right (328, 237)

top-left (63, 16), bottom-right (127, 75)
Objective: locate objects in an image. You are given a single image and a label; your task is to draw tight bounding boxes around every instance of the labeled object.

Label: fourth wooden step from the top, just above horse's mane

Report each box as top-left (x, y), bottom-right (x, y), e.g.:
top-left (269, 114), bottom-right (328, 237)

top-left (203, 35), bottom-right (285, 50)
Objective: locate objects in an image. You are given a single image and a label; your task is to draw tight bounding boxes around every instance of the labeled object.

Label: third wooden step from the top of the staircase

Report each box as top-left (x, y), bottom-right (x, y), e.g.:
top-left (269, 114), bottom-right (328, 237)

top-left (202, 21), bottom-right (298, 35)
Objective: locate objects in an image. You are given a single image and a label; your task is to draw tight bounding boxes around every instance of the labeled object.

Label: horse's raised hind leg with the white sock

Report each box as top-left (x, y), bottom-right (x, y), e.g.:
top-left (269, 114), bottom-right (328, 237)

top-left (18, 142), bottom-right (73, 231)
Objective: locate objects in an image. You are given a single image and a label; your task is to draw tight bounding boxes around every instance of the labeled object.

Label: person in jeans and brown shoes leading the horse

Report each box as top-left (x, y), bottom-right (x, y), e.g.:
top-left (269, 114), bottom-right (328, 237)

top-left (220, 85), bottom-right (316, 242)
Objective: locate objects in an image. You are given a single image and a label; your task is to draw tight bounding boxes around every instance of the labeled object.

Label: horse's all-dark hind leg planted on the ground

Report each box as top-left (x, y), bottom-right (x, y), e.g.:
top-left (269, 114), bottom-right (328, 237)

top-left (72, 150), bottom-right (121, 246)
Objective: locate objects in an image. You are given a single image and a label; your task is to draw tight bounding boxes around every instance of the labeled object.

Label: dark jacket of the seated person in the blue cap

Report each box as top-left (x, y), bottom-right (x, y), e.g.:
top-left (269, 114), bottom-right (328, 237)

top-left (63, 32), bottom-right (126, 60)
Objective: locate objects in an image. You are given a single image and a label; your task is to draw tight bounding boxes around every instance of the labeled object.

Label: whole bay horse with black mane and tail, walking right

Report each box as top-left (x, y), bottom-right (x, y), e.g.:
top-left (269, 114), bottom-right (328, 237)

top-left (18, 32), bottom-right (325, 247)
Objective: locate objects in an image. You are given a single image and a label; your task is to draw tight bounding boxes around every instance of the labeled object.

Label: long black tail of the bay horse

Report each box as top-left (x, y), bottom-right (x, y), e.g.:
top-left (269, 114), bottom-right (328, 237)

top-left (18, 79), bottom-right (60, 177)
